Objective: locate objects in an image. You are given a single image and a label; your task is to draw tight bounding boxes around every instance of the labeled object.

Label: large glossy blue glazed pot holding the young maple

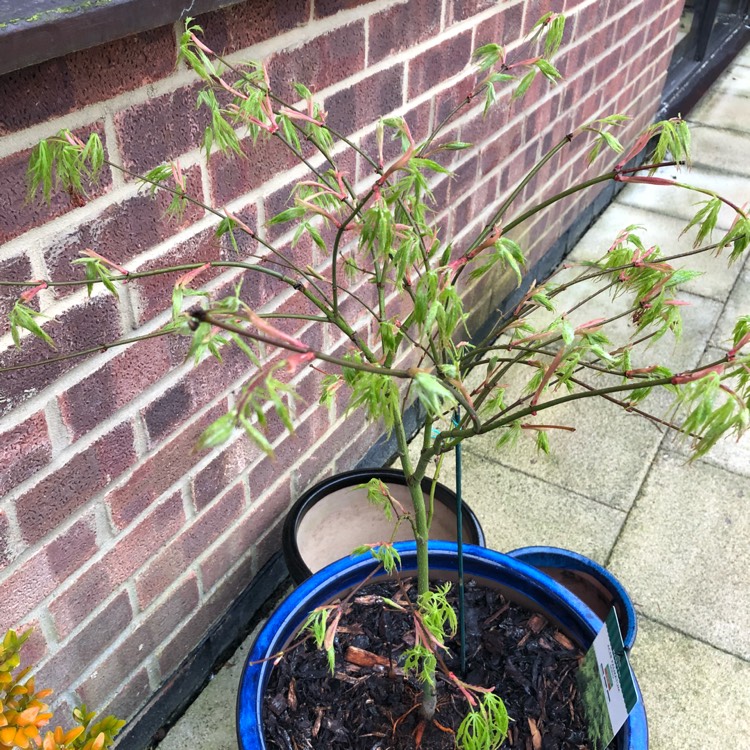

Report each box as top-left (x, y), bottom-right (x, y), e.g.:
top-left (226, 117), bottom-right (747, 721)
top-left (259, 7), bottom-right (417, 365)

top-left (237, 542), bottom-right (648, 750)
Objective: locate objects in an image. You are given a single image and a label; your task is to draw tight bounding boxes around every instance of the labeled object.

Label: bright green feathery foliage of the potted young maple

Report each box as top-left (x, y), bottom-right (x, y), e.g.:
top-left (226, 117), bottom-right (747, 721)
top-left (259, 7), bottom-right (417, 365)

top-left (10, 13), bottom-right (750, 750)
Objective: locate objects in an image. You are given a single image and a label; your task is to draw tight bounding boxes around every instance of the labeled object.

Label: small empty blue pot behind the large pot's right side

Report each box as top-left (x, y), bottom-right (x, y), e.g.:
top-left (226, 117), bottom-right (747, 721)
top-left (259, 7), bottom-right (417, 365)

top-left (508, 547), bottom-right (638, 651)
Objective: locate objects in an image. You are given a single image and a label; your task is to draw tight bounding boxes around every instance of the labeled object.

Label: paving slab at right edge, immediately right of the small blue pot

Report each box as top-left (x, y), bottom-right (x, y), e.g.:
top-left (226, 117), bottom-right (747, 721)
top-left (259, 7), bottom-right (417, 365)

top-left (610, 453), bottom-right (750, 659)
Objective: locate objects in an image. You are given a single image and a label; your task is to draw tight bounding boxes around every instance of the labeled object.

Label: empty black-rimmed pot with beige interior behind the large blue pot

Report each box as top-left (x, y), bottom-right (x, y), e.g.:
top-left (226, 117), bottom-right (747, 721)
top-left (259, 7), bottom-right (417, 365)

top-left (282, 469), bottom-right (486, 583)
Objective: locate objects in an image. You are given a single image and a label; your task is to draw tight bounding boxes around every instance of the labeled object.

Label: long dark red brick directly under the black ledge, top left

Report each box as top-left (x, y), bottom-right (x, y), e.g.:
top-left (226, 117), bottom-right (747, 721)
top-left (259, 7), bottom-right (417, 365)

top-left (0, 26), bottom-right (175, 135)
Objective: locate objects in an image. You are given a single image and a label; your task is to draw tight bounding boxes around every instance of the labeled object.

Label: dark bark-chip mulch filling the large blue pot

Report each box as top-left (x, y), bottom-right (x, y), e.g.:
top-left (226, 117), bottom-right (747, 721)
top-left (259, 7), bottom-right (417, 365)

top-left (263, 582), bottom-right (589, 750)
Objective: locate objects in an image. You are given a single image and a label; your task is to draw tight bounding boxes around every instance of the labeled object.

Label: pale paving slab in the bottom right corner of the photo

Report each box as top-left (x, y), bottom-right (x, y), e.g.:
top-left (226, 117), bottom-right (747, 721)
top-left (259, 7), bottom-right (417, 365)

top-left (631, 617), bottom-right (750, 750)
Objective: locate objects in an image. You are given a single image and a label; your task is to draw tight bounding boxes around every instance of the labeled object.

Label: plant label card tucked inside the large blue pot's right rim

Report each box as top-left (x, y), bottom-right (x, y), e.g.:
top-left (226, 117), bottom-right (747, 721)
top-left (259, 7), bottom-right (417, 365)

top-left (578, 609), bottom-right (638, 750)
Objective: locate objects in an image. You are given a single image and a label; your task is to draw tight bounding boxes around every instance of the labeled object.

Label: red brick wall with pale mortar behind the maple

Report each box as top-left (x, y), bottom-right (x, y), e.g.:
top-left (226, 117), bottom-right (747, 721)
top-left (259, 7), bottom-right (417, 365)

top-left (0, 0), bottom-right (682, 736)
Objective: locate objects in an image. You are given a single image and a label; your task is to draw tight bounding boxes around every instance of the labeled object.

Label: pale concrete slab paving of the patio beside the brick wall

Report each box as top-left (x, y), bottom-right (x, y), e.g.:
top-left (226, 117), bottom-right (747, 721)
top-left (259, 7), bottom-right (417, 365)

top-left (160, 49), bottom-right (750, 750)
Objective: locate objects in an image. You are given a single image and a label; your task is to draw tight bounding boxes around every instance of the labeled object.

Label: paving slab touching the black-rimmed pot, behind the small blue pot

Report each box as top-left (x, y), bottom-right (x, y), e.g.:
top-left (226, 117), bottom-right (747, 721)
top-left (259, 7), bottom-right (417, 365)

top-left (462, 441), bottom-right (625, 564)
